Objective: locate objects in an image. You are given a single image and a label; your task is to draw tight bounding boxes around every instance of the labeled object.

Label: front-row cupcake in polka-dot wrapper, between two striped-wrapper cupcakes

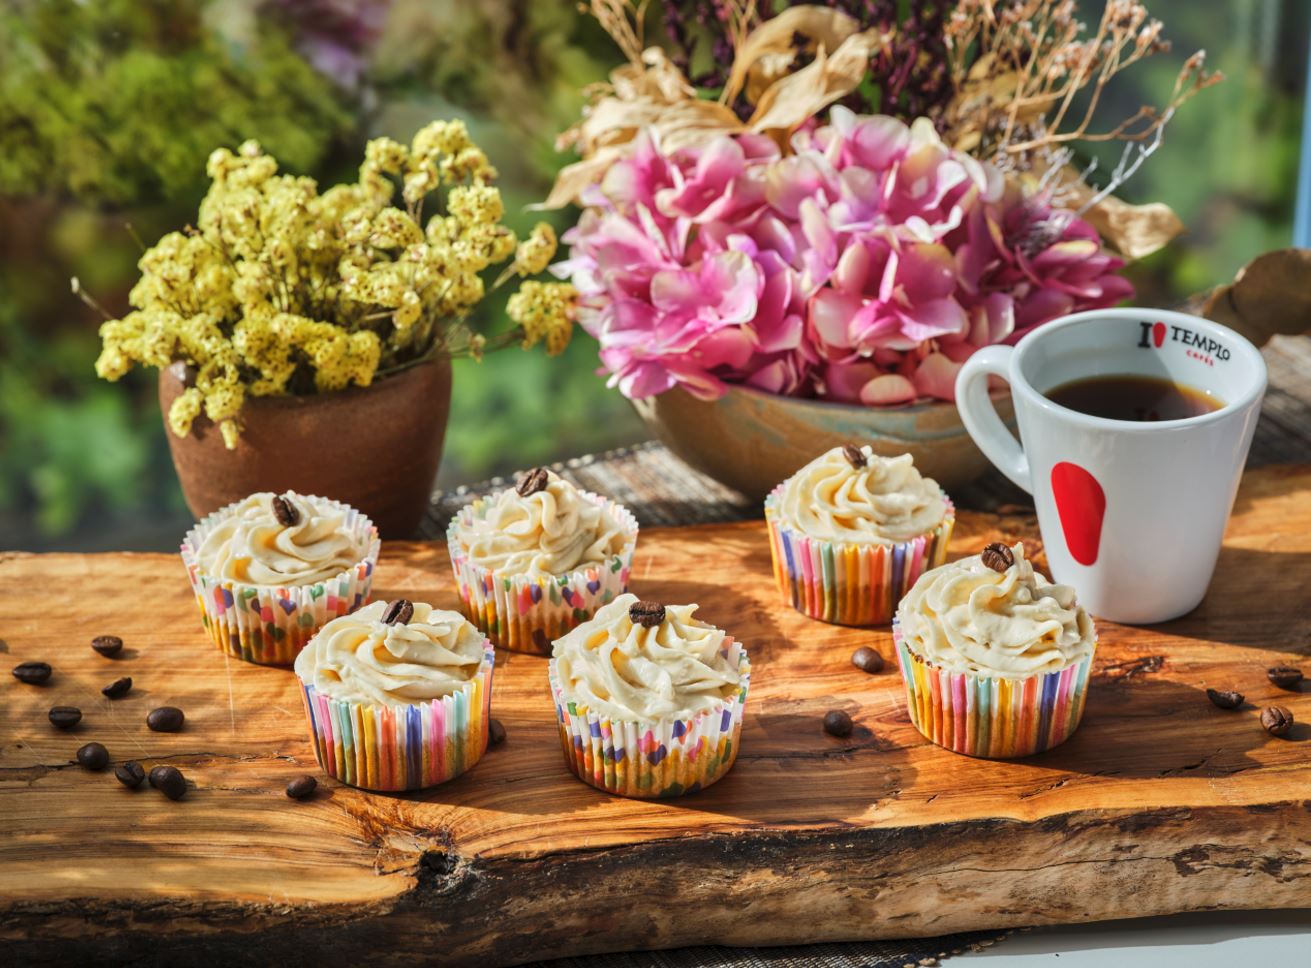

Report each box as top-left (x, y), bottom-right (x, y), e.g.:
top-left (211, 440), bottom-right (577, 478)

top-left (548, 594), bottom-right (751, 797)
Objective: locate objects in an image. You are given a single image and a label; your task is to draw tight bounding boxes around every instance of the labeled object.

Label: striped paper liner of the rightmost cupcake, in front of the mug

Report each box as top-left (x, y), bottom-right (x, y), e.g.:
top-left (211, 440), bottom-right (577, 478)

top-left (893, 626), bottom-right (1092, 759)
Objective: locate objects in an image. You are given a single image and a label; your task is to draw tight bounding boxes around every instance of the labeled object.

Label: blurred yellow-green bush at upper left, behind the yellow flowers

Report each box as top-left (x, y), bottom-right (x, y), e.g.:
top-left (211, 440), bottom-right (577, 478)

top-left (0, 0), bottom-right (355, 206)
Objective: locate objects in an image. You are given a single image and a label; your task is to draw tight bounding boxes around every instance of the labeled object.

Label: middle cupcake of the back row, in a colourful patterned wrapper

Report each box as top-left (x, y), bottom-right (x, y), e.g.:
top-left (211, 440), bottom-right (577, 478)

top-left (446, 467), bottom-right (637, 656)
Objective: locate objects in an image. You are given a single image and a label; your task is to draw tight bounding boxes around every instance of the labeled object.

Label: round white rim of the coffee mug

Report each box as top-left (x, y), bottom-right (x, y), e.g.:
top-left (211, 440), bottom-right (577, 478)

top-left (1007, 307), bottom-right (1268, 434)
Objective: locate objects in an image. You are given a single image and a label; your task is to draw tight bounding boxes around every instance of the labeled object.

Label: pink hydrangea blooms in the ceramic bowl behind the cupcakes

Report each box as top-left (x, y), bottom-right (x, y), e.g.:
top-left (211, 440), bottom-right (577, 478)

top-left (555, 106), bottom-right (1133, 407)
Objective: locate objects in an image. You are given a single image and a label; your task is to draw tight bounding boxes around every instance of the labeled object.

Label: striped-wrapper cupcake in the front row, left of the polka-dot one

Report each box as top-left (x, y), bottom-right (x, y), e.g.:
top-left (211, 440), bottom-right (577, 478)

top-left (295, 598), bottom-right (494, 791)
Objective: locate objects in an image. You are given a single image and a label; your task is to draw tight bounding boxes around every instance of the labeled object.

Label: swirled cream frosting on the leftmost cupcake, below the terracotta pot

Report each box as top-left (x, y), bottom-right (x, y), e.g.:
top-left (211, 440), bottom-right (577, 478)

top-left (197, 492), bottom-right (367, 585)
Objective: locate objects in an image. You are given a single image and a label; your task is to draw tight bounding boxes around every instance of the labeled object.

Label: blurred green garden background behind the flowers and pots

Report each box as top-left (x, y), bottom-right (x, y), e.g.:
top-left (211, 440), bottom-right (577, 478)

top-left (0, 0), bottom-right (1308, 550)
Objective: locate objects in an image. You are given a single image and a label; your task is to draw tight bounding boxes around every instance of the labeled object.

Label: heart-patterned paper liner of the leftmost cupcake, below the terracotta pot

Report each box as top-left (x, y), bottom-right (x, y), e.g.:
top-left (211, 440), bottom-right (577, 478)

top-left (182, 496), bottom-right (382, 665)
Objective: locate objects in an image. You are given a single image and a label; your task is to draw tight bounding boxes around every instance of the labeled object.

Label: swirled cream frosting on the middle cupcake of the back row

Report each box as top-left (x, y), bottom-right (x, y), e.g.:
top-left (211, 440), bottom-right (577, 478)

top-left (455, 472), bottom-right (628, 575)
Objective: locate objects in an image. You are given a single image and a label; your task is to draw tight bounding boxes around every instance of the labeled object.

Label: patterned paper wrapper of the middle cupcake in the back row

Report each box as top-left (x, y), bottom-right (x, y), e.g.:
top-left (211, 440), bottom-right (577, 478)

top-left (446, 491), bottom-right (637, 656)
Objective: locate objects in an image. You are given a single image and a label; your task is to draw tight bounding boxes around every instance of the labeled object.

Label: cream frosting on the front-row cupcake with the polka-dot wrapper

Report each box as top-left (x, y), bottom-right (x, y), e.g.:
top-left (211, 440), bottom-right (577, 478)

top-left (553, 594), bottom-right (739, 720)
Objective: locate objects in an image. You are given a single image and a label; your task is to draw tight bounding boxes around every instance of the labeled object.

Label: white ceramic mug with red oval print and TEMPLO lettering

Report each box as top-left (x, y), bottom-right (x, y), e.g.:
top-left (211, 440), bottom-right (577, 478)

top-left (956, 310), bottom-right (1265, 624)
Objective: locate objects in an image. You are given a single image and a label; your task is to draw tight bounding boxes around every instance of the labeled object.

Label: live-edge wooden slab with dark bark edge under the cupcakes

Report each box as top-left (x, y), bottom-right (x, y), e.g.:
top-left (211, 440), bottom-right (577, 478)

top-left (0, 467), bottom-right (1311, 965)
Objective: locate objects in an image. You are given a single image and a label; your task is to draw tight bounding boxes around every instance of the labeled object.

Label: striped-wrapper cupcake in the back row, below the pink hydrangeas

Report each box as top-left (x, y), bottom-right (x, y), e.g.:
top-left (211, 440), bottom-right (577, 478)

top-left (764, 443), bottom-right (956, 626)
